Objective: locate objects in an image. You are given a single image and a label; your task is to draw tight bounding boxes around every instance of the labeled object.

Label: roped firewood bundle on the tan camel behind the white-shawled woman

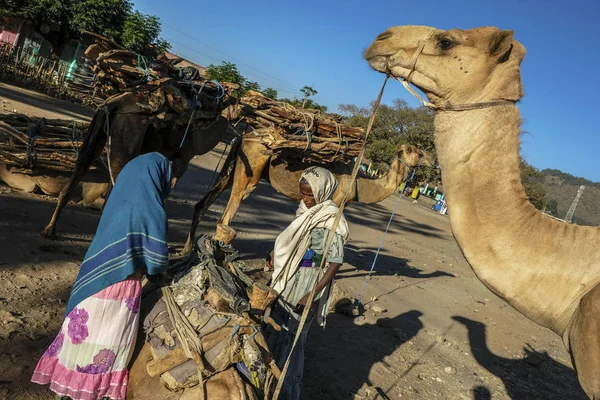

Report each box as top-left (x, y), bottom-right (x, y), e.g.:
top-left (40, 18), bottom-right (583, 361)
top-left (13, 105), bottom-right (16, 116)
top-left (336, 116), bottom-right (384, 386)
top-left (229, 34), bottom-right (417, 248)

top-left (240, 91), bottom-right (363, 164)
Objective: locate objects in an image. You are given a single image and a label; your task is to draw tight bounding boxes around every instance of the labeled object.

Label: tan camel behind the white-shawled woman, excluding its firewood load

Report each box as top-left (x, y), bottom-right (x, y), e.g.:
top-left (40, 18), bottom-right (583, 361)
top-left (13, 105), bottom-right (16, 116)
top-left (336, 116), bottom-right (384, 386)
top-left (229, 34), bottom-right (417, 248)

top-left (182, 132), bottom-right (435, 255)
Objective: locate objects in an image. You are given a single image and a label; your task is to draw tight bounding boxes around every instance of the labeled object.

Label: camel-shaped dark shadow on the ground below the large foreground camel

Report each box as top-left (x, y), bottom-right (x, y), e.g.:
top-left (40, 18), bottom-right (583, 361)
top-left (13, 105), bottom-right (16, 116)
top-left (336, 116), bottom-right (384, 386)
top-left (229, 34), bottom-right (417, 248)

top-left (452, 316), bottom-right (588, 400)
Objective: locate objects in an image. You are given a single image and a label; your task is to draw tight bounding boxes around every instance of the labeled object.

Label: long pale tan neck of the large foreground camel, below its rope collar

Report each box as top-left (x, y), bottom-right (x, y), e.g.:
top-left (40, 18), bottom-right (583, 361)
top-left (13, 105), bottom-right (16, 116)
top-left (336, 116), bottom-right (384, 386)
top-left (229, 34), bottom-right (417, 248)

top-left (435, 106), bottom-right (600, 334)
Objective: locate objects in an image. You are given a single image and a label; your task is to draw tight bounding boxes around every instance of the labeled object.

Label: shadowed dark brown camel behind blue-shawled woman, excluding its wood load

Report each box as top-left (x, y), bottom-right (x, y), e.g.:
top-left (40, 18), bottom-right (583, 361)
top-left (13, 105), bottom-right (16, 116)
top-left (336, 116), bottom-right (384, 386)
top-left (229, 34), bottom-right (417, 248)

top-left (42, 92), bottom-right (233, 236)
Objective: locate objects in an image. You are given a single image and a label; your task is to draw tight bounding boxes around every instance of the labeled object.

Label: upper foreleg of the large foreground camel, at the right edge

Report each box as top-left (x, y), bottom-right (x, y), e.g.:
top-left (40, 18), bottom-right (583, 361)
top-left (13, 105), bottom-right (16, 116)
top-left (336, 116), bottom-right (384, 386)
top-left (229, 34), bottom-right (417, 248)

top-left (568, 285), bottom-right (600, 400)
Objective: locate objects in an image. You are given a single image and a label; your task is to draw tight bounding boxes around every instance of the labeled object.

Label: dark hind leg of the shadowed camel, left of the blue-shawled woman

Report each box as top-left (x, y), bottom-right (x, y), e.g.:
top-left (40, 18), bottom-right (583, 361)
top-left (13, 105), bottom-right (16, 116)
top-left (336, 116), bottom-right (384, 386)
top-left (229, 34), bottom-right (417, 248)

top-left (42, 112), bottom-right (106, 237)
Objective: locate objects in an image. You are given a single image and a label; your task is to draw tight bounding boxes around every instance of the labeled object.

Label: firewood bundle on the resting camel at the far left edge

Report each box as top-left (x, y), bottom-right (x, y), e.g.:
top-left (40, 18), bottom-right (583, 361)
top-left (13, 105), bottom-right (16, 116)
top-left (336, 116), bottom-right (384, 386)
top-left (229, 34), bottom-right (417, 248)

top-left (0, 114), bottom-right (89, 172)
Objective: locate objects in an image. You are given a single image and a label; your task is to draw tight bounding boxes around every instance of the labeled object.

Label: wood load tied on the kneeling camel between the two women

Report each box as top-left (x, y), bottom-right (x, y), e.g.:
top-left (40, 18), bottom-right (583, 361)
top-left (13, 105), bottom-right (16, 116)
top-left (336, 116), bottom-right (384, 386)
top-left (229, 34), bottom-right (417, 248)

top-left (144, 235), bottom-right (281, 398)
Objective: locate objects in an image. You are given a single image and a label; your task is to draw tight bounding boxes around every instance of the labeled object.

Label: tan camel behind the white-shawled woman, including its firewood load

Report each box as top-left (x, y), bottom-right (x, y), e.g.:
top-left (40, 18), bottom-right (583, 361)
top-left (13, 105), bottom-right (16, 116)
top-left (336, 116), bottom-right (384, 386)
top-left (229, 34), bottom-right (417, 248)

top-left (182, 91), bottom-right (435, 255)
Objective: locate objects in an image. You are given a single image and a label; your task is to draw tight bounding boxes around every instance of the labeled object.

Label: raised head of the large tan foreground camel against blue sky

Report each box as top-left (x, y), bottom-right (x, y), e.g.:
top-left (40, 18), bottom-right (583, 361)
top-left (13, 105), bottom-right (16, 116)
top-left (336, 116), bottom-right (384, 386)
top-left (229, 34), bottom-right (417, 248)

top-left (364, 26), bottom-right (525, 107)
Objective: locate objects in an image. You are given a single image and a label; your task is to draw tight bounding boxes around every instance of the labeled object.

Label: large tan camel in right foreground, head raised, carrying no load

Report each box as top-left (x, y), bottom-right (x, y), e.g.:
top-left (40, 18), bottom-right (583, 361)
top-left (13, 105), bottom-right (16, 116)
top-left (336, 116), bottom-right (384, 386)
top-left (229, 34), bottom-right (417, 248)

top-left (365, 26), bottom-right (600, 399)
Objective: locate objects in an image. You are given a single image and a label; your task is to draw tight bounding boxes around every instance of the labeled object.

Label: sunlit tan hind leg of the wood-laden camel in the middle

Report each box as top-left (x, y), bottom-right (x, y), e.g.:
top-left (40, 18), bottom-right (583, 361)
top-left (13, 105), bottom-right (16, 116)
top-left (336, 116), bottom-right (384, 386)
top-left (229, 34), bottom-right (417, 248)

top-left (219, 142), bottom-right (270, 226)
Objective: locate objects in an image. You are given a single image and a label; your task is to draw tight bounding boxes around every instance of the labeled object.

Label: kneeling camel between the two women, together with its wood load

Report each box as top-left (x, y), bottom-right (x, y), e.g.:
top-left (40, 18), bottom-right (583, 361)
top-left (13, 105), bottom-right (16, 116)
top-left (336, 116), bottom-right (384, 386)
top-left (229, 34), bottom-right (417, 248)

top-left (127, 235), bottom-right (280, 400)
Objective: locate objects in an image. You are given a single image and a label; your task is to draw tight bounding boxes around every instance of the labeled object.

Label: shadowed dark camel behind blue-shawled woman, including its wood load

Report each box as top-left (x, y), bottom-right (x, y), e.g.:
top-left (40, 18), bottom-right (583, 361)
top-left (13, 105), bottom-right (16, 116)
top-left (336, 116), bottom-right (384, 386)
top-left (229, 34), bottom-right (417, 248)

top-left (42, 35), bottom-right (237, 236)
